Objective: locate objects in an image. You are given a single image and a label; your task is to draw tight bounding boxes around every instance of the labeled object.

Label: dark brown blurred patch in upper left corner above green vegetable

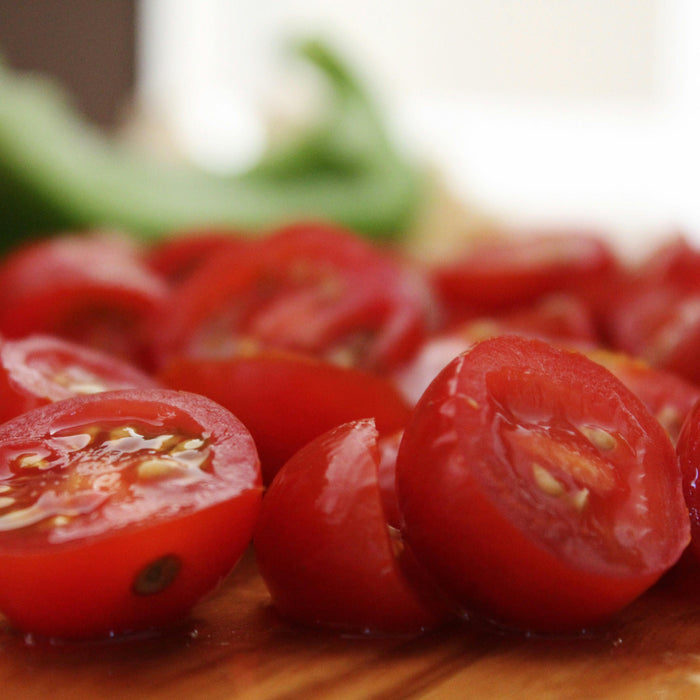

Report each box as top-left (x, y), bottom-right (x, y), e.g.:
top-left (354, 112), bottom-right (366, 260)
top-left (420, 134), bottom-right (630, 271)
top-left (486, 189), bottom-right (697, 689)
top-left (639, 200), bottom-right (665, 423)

top-left (0, 0), bottom-right (136, 127)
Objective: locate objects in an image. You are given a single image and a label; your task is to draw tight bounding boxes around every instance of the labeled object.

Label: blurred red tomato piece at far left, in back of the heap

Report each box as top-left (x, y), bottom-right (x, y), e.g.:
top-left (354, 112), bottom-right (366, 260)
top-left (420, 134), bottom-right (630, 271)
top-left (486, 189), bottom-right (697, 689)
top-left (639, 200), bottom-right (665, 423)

top-left (0, 233), bottom-right (166, 366)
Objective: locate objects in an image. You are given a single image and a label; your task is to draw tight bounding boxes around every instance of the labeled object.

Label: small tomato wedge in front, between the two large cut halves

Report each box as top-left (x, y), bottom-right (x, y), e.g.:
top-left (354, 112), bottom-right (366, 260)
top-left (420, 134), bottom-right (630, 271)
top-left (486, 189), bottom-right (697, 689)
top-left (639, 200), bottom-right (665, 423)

top-left (254, 420), bottom-right (441, 634)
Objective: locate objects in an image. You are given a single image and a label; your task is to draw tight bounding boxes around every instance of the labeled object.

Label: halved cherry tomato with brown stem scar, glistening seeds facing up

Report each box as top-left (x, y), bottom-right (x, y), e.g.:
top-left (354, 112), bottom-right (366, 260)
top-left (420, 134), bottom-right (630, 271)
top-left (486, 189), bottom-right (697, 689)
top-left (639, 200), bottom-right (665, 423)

top-left (0, 389), bottom-right (262, 638)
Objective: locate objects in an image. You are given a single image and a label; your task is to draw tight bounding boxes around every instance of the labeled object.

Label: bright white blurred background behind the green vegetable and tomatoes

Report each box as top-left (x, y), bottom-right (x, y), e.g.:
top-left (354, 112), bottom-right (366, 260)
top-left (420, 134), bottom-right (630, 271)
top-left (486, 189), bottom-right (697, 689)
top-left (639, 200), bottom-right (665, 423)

top-left (137, 0), bottom-right (700, 254)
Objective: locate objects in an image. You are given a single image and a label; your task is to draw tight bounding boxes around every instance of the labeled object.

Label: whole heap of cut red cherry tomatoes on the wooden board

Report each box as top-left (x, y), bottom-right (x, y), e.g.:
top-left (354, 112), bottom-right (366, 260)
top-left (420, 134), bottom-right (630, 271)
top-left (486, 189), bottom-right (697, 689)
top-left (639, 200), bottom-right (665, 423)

top-left (0, 222), bottom-right (700, 638)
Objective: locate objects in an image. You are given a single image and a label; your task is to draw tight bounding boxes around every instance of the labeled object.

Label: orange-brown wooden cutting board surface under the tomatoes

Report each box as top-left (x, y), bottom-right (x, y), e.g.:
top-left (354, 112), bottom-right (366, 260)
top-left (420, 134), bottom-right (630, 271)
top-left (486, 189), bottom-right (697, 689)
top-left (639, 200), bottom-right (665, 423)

top-left (0, 554), bottom-right (700, 700)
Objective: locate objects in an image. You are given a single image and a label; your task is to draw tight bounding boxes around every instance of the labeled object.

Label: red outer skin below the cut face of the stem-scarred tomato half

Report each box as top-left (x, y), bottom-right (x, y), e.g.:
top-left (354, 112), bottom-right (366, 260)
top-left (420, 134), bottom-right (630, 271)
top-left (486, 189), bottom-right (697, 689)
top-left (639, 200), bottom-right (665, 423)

top-left (0, 490), bottom-right (260, 640)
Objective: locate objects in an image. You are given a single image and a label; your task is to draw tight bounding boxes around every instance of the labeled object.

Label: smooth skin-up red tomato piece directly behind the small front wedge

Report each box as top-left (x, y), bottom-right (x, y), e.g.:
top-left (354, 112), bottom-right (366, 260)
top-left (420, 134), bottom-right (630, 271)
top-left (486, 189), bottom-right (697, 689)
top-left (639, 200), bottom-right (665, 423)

top-left (159, 350), bottom-right (409, 483)
